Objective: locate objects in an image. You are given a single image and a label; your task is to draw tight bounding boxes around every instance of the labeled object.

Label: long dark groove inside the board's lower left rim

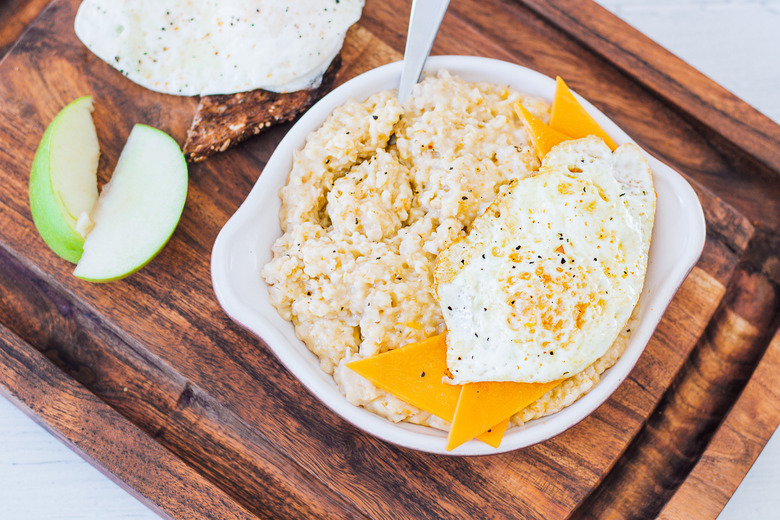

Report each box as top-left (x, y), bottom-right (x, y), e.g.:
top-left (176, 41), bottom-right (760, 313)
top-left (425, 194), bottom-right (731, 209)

top-left (0, 243), bottom-right (372, 518)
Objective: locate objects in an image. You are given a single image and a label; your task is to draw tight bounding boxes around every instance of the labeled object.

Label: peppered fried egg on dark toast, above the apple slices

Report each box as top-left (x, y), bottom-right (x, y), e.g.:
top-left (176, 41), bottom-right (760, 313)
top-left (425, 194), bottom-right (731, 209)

top-left (75, 0), bottom-right (363, 96)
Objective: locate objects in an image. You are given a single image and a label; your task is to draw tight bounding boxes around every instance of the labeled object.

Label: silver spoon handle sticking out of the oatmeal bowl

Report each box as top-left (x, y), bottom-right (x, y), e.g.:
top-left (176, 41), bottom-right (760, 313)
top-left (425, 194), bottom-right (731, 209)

top-left (398, 0), bottom-right (450, 103)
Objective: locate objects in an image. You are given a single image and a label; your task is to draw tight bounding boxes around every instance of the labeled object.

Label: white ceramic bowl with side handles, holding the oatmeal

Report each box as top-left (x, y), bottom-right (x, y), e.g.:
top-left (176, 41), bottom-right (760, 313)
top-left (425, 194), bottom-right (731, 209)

top-left (211, 56), bottom-right (705, 455)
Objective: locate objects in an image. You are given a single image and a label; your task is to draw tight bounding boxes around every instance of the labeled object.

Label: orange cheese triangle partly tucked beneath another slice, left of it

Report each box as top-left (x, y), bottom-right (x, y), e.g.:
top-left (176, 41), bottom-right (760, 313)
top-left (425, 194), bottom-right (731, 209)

top-left (347, 333), bottom-right (508, 448)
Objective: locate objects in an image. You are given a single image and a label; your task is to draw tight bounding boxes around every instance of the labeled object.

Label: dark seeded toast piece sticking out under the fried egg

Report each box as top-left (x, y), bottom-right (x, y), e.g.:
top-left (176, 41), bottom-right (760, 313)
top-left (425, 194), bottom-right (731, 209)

top-left (184, 56), bottom-right (341, 162)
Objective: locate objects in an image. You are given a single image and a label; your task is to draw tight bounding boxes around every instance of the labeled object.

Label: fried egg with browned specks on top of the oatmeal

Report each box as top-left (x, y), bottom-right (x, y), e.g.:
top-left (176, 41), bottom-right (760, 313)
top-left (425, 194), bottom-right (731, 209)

top-left (434, 137), bottom-right (655, 384)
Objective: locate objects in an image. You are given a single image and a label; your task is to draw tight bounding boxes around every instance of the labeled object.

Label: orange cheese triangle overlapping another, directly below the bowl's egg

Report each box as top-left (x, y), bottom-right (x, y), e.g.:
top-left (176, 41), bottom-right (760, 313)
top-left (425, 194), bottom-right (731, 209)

top-left (447, 381), bottom-right (560, 451)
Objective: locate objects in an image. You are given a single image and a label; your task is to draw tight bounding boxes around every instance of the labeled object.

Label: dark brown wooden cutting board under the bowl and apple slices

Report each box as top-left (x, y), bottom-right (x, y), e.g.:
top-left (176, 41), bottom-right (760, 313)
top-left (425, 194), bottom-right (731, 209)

top-left (0, 0), bottom-right (780, 519)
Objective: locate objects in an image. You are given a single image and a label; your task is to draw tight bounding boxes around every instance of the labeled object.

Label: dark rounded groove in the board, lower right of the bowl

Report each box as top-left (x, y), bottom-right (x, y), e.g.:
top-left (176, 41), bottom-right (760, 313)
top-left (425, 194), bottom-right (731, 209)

top-left (573, 270), bottom-right (777, 518)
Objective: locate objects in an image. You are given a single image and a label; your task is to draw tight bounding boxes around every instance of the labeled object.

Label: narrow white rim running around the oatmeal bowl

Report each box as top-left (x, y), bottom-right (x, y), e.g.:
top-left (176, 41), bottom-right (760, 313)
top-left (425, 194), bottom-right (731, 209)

top-left (211, 56), bottom-right (706, 455)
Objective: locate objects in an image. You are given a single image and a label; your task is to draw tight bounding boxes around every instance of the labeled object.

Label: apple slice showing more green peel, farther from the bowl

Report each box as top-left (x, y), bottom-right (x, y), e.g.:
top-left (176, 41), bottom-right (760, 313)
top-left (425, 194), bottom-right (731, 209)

top-left (30, 96), bottom-right (100, 263)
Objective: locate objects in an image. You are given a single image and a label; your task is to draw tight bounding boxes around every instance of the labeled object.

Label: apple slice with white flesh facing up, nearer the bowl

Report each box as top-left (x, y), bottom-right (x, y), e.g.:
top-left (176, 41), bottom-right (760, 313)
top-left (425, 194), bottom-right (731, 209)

top-left (73, 125), bottom-right (187, 282)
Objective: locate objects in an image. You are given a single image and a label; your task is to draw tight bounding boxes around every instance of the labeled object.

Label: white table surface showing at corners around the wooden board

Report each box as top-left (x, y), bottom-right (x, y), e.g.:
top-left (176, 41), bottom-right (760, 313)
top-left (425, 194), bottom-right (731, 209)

top-left (0, 0), bottom-right (780, 520)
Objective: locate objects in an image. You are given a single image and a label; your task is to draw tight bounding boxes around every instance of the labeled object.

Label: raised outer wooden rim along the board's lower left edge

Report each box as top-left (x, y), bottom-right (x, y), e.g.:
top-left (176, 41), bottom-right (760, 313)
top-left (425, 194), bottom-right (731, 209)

top-left (0, 320), bottom-right (254, 520)
